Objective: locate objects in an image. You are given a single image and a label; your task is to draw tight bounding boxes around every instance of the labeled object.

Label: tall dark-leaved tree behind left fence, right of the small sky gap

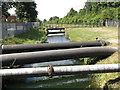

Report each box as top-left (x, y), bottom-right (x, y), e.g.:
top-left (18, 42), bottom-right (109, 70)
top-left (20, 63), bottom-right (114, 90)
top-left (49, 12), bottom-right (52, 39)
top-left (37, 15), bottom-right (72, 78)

top-left (15, 2), bottom-right (38, 22)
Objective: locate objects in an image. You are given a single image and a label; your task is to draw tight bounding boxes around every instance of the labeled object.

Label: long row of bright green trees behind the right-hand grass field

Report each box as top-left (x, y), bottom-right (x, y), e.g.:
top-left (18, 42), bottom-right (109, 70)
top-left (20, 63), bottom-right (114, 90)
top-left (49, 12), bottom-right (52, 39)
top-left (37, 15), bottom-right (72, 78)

top-left (44, 0), bottom-right (120, 25)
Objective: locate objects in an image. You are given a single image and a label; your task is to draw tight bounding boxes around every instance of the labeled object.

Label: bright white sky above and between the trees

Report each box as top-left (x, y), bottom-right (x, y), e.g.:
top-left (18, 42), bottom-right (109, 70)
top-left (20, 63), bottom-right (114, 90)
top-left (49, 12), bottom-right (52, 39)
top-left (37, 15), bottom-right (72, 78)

top-left (9, 0), bottom-right (87, 20)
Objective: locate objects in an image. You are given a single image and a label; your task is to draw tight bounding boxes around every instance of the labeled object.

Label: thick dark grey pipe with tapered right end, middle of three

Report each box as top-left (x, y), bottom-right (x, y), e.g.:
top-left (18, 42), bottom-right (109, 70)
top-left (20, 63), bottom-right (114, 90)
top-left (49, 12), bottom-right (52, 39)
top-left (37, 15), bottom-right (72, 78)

top-left (0, 47), bottom-right (117, 66)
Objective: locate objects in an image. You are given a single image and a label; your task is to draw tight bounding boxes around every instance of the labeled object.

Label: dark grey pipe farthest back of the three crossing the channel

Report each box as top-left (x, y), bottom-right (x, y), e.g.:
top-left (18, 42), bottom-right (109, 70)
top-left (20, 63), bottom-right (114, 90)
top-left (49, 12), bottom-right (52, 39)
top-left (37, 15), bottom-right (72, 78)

top-left (2, 41), bottom-right (110, 54)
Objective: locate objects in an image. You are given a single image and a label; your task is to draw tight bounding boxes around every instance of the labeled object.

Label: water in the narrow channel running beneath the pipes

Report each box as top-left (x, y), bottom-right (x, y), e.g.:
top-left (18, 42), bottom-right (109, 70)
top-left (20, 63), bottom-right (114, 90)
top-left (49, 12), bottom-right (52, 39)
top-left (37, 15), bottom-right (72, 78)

top-left (4, 34), bottom-right (90, 88)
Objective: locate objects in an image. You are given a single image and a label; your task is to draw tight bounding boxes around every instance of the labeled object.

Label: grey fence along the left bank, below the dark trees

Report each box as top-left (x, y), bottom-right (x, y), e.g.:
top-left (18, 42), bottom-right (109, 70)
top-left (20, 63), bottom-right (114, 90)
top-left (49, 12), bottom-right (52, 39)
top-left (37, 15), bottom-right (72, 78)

top-left (0, 22), bottom-right (40, 39)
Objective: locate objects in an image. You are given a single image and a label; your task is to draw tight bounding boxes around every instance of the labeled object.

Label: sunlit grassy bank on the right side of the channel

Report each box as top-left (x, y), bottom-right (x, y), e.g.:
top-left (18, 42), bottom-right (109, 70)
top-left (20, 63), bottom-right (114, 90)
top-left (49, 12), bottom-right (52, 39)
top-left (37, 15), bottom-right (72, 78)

top-left (66, 27), bottom-right (120, 88)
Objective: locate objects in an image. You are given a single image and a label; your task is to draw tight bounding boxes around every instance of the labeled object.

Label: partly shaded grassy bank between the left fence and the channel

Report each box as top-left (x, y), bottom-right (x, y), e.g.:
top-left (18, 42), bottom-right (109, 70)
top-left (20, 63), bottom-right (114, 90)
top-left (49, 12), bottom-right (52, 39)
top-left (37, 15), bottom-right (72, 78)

top-left (2, 26), bottom-right (47, 45)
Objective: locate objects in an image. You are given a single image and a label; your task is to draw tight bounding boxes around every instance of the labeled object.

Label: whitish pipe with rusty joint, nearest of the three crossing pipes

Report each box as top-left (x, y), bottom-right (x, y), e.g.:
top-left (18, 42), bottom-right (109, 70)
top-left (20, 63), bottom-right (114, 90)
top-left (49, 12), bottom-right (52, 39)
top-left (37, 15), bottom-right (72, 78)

top-left (0, 64), bottom-right (120, 77)
